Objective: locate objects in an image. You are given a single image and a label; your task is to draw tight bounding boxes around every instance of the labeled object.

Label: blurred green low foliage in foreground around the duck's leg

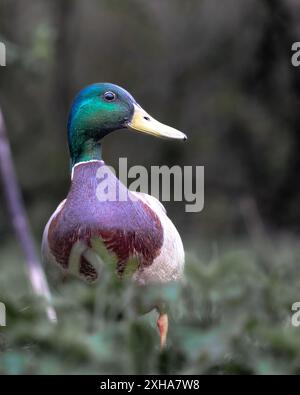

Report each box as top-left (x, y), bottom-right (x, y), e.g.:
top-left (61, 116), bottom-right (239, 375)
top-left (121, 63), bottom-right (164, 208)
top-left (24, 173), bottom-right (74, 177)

top-left (0, 239), bottom-right (300, 374)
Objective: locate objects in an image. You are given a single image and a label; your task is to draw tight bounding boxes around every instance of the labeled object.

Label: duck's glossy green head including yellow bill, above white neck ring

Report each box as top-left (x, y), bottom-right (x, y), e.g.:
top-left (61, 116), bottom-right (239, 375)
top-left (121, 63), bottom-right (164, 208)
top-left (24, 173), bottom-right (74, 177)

top-left (68, 83), bottom-right (186, 166)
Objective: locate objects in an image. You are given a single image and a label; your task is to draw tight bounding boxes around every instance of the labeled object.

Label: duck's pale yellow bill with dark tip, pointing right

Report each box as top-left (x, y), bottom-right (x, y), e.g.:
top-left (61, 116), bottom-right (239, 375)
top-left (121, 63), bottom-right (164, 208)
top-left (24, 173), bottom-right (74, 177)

top-left (128, 104), bottom-right (187, 141)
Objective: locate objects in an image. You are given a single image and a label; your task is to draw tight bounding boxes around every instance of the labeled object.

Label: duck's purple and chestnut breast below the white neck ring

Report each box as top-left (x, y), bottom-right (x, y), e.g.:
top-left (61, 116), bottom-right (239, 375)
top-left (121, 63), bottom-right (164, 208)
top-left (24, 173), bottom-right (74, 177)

top-left (44, 161), bottom-right (164, 282)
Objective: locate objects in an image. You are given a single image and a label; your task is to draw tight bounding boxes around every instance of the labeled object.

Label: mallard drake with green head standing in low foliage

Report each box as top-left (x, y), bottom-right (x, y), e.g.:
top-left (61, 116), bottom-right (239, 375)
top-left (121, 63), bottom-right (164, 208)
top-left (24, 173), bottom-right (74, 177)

top-left (42, 83), bottom-right (187, 346)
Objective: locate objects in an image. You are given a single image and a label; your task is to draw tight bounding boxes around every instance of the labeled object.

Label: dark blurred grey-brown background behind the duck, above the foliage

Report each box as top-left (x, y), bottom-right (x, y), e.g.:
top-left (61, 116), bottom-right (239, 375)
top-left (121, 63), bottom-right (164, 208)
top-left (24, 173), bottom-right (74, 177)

top-left (0, 0), bottom-right (300, 378)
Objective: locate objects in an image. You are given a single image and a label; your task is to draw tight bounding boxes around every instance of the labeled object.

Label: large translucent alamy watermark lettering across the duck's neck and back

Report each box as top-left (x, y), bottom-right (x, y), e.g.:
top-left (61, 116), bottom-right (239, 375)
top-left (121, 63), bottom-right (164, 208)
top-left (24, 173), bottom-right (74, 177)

top-left (96, 158), bottom-right (204, 213)
